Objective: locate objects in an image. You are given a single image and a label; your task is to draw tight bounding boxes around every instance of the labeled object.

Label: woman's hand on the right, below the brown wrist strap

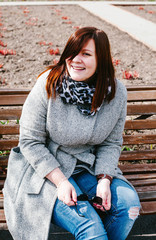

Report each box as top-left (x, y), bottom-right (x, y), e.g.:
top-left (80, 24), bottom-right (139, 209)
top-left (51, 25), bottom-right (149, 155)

top-left (96, 178), bottom-right (111, 210)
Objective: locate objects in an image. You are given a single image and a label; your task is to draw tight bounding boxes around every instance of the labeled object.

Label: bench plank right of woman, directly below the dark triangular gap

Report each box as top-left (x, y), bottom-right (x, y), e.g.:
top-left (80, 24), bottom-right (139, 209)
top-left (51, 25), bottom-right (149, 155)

top-left (125, 119), bottom-right (156, 130)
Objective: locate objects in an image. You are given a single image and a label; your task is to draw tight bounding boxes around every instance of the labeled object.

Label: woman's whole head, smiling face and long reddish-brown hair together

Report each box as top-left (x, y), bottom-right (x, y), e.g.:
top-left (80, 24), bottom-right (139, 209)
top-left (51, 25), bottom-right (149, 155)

top-left (46, 27), bottom-right (115, 111)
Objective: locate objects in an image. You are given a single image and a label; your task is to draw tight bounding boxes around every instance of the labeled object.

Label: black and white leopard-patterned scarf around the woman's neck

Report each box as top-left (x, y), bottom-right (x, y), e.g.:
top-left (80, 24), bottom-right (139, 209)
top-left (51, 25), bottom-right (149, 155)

top-left (56, 76), bottom-right (109, 116)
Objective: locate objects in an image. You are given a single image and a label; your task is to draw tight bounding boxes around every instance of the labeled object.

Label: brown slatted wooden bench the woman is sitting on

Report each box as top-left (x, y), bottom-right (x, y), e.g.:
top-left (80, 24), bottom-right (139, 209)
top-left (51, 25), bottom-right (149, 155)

top-left (0, 86), bottom-right (156, 230)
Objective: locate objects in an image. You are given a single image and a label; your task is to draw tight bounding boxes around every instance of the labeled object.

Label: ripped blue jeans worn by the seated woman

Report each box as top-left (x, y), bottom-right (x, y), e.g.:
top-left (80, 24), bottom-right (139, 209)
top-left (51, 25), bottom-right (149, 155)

top-left (52, 171), bottom-right (140, 240)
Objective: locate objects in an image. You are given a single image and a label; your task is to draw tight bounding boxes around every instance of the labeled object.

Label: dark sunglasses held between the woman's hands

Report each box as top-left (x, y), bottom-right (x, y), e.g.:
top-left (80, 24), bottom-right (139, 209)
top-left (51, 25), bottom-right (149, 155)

top-left (75, 194), bottom-right (108, 217)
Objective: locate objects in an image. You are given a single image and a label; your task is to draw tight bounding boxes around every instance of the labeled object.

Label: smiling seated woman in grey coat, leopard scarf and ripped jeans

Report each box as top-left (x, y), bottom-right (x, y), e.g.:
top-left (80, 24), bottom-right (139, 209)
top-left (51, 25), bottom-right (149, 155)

top-left (3, 27), bottom-right (140, 240)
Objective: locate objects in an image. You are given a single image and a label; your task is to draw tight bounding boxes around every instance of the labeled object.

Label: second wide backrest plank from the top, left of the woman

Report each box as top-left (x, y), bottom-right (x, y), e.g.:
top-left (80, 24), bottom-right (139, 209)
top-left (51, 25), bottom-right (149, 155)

top-left (0, 108), bottom-right (22, 120)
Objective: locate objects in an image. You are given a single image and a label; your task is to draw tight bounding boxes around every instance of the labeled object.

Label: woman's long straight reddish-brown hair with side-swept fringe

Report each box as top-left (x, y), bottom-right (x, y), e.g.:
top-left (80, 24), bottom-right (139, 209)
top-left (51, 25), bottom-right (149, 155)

top-left (42, 27), bottom-right (115, 111)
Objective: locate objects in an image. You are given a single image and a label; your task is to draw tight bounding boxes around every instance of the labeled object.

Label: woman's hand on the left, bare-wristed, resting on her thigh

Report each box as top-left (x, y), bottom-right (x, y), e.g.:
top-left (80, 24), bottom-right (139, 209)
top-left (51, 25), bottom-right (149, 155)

top-left (57, 179), bottom-right (77, 206)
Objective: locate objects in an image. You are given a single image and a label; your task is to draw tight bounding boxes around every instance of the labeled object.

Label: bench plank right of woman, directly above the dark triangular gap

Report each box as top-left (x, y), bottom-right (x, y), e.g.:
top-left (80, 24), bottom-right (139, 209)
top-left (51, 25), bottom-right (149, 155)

top-left (127, 103), bottom-right (156, 115)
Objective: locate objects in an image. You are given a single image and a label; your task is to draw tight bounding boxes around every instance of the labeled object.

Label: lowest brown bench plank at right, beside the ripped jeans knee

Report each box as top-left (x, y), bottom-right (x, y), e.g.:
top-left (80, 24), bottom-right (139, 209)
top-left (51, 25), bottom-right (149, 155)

top-left (140, 201), bottom-right (156, 215)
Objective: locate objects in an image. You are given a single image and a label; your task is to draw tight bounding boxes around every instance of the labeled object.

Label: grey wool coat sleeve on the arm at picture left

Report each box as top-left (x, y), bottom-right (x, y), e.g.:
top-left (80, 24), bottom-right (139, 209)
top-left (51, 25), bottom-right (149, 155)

top-left (19, 72), bottom-right (60, 178)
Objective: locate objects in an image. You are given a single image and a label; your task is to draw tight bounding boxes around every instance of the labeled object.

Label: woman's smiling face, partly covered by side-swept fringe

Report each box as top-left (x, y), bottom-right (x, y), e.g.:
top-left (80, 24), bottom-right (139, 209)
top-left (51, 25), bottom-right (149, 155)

top-left (66, 39), bottom-right (97, 81)
